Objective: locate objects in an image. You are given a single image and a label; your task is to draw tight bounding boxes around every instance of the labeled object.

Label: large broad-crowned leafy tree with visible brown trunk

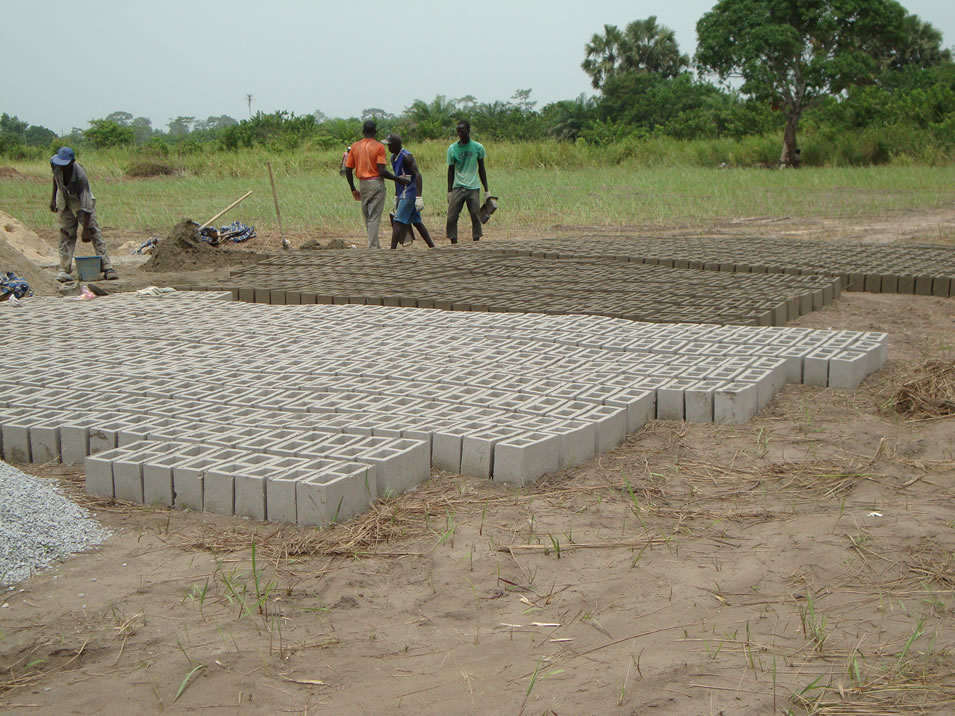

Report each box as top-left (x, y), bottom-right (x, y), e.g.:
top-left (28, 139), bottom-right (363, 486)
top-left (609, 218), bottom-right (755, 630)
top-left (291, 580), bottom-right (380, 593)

top-left (696, 0), bottom-right (928, 166)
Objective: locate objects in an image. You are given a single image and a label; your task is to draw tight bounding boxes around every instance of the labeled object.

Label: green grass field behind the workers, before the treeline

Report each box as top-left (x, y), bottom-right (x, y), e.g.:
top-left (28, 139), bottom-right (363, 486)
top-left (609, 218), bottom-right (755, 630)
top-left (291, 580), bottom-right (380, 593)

top-left (0, 143), bottom-right (955, 236)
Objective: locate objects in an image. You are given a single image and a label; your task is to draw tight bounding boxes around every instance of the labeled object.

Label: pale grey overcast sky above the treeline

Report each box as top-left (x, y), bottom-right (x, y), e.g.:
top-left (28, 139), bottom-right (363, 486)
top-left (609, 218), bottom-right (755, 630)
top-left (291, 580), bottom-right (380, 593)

top-left (0, 0), bottom-right (955, 134)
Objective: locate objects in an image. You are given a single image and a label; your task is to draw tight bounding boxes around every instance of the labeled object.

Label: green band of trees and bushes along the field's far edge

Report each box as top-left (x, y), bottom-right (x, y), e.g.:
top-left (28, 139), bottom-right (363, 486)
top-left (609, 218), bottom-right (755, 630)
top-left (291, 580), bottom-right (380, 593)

top-left (0, 0), bottom-right (955, 168)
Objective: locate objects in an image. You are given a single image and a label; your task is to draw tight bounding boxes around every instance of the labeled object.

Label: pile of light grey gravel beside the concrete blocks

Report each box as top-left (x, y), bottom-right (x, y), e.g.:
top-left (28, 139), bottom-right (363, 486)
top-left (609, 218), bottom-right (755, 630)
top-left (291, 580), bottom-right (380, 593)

top-left (0, 462), bottom-right (109, 584)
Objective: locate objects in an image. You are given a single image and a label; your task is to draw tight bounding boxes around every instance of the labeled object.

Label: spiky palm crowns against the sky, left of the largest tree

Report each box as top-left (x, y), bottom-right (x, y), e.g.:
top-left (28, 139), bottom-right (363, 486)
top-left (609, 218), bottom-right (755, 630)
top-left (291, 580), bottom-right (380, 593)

top-left (580, 15), bottom-right (690, 89)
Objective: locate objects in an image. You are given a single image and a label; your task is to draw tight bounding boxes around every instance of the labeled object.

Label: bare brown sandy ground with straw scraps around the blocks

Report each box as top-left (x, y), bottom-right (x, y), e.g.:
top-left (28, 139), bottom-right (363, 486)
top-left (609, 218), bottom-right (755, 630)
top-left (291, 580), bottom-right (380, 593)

top-left (0, 212), bottom-right (955, 715)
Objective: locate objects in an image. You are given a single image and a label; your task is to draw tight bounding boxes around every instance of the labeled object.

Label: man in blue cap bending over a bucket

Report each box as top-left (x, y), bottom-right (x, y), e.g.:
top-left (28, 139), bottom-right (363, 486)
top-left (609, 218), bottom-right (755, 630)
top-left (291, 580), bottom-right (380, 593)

top-left (50, 147), bottom-right (119, 283)
